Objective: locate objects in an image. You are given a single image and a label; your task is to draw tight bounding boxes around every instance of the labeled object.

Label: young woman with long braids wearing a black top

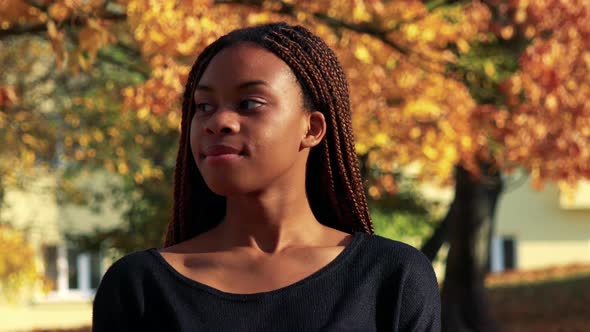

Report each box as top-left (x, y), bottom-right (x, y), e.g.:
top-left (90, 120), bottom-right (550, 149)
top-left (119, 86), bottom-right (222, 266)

top-left (93, 23), bottom-right (440, 331)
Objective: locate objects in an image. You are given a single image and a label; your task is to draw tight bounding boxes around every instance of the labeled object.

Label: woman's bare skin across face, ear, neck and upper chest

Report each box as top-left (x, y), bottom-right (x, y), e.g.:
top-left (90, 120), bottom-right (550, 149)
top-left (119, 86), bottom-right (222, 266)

top-left (160, 43), bottom-right (351, 294)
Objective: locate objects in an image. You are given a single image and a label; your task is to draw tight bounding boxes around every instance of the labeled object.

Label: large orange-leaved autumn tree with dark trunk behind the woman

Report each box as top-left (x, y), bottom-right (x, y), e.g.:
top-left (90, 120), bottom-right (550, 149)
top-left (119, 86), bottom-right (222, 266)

top-left (0, 0), bottom-right (590, 331)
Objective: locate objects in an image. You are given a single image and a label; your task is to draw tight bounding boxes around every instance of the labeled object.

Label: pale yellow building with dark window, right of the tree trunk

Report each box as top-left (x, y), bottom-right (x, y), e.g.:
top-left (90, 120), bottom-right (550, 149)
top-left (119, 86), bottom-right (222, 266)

top-left (491, 181), bottom-right (590, 271)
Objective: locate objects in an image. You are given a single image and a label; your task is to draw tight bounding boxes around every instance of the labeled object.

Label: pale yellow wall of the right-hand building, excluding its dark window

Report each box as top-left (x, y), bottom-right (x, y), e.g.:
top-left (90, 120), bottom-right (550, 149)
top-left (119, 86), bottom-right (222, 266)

top-left (496, 182), bottom-right (590, 269)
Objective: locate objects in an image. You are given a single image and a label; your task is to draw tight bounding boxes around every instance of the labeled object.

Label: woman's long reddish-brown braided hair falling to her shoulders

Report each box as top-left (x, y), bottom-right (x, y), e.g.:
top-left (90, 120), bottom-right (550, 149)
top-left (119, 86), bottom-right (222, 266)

top-left (165, 23), bottom-right (373, 246)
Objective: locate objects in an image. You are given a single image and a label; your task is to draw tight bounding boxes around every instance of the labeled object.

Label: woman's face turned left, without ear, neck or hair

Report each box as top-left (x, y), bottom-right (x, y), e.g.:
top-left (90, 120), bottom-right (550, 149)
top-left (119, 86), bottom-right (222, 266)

top-left (190, 43), bottom-right (320, 196)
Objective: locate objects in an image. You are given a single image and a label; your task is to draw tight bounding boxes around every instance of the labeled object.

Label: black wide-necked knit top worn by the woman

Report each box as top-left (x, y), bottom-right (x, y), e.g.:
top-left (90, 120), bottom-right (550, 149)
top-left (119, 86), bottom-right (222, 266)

top-left (92, 233), bottom-right (440, 332)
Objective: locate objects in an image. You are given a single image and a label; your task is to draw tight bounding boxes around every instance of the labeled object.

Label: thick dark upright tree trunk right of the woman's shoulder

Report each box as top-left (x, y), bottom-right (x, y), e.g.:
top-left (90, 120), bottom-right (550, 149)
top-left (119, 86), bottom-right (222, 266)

top-left (442, 165), bottom-right (502, 332)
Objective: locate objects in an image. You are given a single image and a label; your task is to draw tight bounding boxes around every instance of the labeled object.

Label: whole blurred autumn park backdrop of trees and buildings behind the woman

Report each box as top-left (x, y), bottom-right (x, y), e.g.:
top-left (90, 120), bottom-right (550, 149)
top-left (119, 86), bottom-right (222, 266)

top-left (0, 0), bottom-right (590, 331)
